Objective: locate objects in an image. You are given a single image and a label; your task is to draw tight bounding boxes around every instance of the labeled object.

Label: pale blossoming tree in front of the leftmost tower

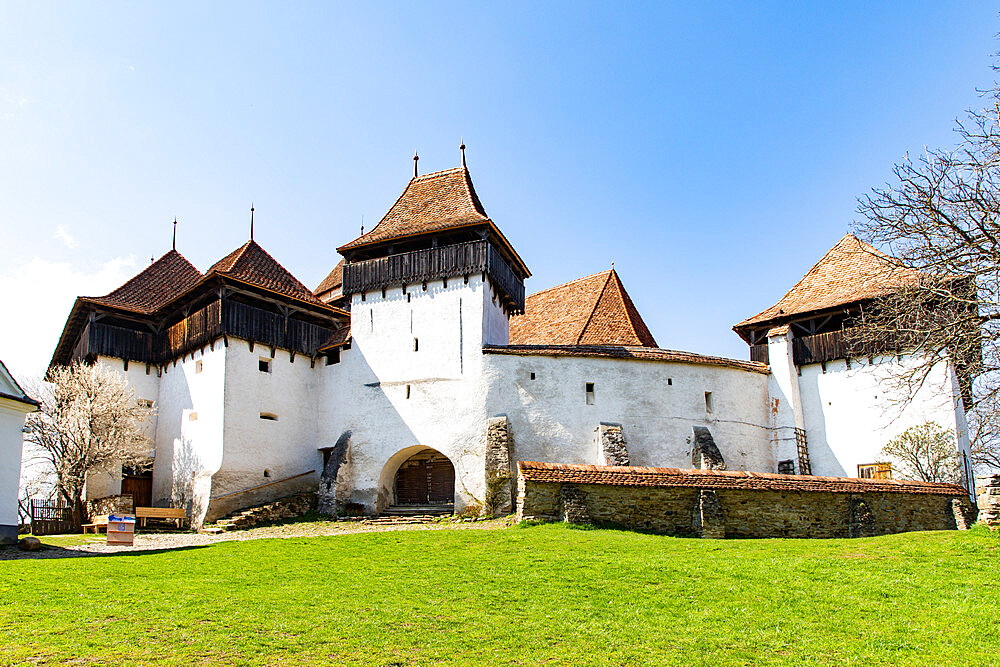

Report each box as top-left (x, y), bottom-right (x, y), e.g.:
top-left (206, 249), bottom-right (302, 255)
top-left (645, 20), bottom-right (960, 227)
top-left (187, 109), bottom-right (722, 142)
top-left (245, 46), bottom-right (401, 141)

top-left (24, 363), bottom-right (153, 523)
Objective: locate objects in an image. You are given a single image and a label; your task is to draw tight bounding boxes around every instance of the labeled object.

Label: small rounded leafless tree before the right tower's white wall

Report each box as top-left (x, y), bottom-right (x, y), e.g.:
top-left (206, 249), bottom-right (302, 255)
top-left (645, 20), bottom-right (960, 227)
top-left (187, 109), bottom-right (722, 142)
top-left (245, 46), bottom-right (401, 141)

top-left (882, 422), bottom-right (960, 483)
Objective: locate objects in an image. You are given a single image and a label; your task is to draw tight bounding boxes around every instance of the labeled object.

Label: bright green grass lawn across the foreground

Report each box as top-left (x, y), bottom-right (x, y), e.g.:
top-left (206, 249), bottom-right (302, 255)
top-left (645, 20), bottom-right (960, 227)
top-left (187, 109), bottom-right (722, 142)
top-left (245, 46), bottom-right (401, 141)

top-left (0, 525), bottom-right (1000, 666)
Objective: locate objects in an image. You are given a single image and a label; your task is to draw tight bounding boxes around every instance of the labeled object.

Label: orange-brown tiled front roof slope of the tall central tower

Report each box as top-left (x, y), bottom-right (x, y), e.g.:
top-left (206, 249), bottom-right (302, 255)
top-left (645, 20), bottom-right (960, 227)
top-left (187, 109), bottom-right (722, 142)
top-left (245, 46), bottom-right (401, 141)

top-left (338, 167), bottom-right (489, 250)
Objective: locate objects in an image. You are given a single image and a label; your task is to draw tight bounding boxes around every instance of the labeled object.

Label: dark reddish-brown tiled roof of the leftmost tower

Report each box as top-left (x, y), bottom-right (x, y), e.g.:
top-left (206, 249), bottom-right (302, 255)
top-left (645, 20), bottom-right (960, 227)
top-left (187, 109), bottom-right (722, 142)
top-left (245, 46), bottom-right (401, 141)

top-left (82, 250), bottom-right (202, 314)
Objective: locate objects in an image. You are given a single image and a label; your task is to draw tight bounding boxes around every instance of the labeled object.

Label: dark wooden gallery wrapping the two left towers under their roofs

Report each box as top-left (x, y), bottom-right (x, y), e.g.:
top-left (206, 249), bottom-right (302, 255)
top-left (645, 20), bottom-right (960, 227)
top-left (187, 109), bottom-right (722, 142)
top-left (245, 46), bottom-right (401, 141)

top-left (73, 299), bottom-right (333, 364)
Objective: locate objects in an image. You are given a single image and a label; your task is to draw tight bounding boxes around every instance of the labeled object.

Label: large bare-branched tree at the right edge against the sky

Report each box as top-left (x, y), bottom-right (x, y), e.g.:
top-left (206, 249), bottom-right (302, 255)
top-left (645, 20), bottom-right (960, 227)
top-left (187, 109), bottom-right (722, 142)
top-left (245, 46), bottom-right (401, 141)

top-left (852, 70), bottom-right (1000, 467)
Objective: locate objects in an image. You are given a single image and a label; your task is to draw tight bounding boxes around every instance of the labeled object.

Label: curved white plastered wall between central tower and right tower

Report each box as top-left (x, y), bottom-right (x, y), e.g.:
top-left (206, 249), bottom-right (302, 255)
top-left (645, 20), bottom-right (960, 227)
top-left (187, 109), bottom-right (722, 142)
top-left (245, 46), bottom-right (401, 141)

top-left (484, 354), bottom-right (774, 471)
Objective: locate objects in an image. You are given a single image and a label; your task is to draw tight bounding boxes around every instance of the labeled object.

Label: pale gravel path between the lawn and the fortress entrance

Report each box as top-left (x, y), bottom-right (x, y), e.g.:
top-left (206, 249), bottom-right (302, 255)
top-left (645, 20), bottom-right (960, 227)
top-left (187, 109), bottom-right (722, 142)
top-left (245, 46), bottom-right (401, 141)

top-left (0, 517), bottom-right (513, 561)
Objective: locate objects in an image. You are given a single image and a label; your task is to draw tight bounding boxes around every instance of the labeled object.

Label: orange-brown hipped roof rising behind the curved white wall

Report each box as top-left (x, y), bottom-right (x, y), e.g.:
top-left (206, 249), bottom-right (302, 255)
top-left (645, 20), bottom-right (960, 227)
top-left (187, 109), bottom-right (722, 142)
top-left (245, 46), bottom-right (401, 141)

top-left (510, 269), bottom-right (656, 348)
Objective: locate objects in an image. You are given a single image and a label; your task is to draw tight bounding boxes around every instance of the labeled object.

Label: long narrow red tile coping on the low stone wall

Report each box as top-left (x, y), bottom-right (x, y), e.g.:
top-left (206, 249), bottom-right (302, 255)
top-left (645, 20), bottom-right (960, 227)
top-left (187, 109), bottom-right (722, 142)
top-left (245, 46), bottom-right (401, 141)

top-left (517, 461), bottom-right (968, 496)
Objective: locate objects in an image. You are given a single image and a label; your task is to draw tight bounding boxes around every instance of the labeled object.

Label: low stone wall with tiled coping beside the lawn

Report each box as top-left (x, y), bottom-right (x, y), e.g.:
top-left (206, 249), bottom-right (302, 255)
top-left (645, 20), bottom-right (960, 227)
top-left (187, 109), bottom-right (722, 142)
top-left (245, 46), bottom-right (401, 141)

top-left (517, 462), bottom-right (971, 537)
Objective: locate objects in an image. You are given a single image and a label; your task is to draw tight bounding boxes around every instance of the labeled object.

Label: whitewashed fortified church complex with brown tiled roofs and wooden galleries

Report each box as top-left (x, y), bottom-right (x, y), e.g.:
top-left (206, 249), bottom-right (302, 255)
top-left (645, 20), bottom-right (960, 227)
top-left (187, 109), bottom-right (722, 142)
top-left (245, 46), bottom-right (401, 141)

top-left (52, 165), bottom-right (969, 525)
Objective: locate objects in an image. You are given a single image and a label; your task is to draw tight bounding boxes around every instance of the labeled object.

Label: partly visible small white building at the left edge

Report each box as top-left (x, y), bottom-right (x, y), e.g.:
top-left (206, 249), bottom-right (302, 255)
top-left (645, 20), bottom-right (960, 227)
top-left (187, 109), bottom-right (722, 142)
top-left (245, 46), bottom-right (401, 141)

top-left (0, 361), bottom-right (38, 544)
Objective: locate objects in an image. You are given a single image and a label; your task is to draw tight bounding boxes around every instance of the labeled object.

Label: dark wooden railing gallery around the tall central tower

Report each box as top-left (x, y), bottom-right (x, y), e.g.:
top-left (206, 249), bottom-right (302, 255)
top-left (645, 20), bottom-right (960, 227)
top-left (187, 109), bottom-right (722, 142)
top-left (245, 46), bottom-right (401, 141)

top-left (343, 241), bottom-right (524, 313)
